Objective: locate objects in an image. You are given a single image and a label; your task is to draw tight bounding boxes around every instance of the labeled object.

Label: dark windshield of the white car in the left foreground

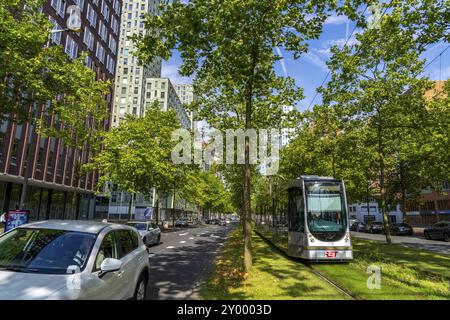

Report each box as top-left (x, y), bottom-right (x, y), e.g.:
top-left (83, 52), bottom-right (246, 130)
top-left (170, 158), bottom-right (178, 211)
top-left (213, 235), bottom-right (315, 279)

top-left (0, 228), bottom-right (96, 274)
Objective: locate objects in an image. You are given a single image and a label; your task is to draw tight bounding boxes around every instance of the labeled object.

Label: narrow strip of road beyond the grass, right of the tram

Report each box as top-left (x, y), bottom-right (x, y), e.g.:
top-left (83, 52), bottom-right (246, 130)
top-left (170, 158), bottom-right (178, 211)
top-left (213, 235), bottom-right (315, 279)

top-left (352, 231), bottom-right (450, 254)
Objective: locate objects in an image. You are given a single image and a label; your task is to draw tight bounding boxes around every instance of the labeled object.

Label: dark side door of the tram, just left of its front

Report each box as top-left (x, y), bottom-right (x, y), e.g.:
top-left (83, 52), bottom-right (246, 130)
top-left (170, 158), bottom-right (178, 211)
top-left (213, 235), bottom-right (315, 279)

top-left (288, 188), bottom-right (305, 257)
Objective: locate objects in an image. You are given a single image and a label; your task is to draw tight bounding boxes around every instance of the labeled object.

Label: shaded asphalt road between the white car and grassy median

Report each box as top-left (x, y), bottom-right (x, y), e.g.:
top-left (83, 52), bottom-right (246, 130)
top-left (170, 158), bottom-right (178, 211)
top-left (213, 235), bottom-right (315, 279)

top-left (147, 225), bottom-right (233, 300)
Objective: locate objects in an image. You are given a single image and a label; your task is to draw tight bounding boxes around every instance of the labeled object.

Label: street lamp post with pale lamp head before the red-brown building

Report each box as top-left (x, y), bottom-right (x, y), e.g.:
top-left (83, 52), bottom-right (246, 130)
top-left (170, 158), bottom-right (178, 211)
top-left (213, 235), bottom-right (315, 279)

top-left (19, 5), bottom-right (81, 210)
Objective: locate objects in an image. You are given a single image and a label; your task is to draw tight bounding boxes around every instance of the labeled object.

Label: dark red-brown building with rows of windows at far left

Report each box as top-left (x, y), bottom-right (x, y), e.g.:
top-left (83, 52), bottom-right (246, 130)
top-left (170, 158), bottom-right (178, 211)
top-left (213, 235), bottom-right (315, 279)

top-left (0, 0), bottom-right (122, 221)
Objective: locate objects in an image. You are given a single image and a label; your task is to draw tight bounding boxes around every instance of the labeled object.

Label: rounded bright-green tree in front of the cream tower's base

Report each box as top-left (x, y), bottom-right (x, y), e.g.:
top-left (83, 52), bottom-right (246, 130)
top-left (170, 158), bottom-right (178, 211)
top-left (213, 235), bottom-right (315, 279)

top-left (91, 103), bottom-right (183, 223)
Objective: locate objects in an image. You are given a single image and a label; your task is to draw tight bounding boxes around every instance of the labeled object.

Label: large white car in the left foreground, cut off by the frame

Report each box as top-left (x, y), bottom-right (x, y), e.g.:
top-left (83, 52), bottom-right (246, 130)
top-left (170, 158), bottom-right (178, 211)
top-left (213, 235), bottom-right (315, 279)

top-left (0, 220), bottom-right (150, 300)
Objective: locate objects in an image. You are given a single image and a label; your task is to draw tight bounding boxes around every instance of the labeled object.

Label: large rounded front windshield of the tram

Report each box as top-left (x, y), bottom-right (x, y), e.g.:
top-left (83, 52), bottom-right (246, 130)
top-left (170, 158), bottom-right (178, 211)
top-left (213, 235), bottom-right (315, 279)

top-left (305, 181), bottom-right (347, 241)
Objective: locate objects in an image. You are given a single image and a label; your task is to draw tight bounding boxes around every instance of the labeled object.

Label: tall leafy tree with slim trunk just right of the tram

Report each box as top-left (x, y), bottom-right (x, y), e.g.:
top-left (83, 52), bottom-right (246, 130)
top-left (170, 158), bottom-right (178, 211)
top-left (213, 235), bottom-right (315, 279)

top-left (321, 1), bottom-right (446, 243)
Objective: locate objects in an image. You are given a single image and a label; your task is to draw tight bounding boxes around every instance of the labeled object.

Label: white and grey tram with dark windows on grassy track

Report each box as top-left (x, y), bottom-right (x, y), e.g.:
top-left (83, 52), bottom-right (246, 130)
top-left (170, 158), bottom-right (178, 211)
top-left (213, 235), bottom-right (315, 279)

top-left (254, 176), bottom-right (353, 261)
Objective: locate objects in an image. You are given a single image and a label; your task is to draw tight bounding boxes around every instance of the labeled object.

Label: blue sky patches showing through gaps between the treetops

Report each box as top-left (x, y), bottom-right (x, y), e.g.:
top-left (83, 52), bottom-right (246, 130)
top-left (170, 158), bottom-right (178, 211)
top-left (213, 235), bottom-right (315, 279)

top-left (162, 11), bottom-right (450, 111)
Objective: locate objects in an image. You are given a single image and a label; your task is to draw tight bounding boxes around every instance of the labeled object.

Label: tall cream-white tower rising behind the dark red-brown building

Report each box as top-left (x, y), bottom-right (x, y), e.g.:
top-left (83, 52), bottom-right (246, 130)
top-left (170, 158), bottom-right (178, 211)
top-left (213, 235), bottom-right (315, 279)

top-left (112, 0), bottom-right (161, 126)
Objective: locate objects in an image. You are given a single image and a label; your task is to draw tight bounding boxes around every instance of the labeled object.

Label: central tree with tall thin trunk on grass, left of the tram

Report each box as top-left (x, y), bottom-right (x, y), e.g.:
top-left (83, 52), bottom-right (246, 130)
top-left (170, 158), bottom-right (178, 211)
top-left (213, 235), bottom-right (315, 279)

top-left (134, 0), bottom-right (351, 270)
